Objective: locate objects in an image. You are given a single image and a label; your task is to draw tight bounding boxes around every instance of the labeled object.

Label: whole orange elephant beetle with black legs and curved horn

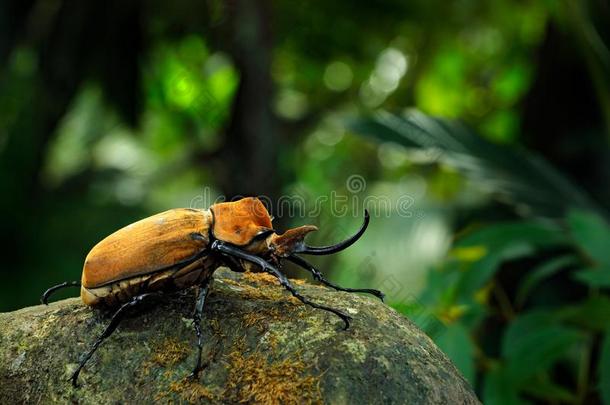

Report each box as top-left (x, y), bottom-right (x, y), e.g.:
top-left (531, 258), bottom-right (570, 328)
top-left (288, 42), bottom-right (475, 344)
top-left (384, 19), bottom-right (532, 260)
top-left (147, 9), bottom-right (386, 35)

top-left (41, 197), bottom-right (383, 386)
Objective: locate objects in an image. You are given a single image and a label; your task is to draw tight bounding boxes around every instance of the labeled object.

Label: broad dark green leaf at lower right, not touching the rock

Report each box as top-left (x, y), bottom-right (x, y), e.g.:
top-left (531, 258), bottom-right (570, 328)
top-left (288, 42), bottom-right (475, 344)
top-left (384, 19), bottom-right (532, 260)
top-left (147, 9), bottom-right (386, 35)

top-left (502, 311), bottom-right (583, 386)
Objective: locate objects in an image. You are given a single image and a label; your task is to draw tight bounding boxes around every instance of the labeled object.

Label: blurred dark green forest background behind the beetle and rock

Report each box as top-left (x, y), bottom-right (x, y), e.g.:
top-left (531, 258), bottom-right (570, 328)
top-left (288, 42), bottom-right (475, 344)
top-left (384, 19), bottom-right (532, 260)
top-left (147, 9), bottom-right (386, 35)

top-left (0, 0), bottom-right (610, 404)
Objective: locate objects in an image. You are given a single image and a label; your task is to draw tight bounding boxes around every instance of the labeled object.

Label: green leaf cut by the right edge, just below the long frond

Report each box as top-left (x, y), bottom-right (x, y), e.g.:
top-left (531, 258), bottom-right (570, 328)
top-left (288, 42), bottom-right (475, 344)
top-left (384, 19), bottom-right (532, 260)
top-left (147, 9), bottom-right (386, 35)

top-left (568, 210), bottom-right (610, 265)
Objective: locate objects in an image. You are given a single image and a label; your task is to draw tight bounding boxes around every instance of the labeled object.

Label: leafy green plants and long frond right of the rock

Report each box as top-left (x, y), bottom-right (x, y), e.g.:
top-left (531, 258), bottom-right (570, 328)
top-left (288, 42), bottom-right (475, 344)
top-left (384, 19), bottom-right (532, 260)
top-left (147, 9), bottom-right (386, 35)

top-left (350, 112), bottom-right (610, 404)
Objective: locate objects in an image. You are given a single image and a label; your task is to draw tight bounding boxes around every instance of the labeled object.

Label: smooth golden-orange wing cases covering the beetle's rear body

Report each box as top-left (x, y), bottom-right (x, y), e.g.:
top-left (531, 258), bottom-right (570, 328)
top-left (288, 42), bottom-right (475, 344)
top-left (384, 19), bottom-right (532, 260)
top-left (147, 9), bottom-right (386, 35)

top-left (81, 208), bottom-right (211, 289)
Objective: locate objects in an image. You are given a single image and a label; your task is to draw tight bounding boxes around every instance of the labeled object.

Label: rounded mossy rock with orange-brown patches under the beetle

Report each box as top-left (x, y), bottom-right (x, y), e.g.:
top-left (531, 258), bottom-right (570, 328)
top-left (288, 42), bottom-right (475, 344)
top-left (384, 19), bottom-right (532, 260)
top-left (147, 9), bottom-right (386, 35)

top-left (0, 269), bottom-right (478, 404)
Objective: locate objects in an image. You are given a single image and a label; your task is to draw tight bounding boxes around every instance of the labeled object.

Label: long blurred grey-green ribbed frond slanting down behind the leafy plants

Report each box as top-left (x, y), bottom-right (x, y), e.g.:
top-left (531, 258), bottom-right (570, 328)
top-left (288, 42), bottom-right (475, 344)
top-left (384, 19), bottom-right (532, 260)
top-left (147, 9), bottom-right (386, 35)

top-left (347, 111), bottom-right (599, 218)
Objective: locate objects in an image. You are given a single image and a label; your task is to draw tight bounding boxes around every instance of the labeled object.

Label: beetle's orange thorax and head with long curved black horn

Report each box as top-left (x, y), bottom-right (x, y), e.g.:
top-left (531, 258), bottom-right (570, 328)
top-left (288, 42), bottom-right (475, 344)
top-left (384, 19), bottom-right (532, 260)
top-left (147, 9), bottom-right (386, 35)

top-left (210, 197), bottom-right (369, 259)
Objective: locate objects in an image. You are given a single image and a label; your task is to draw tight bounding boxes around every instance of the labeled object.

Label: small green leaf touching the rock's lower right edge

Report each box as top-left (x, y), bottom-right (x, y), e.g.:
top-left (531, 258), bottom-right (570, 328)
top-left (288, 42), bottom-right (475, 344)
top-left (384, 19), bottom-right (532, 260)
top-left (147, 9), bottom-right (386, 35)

top-left (435, 322), bottom-right (475, 384)
